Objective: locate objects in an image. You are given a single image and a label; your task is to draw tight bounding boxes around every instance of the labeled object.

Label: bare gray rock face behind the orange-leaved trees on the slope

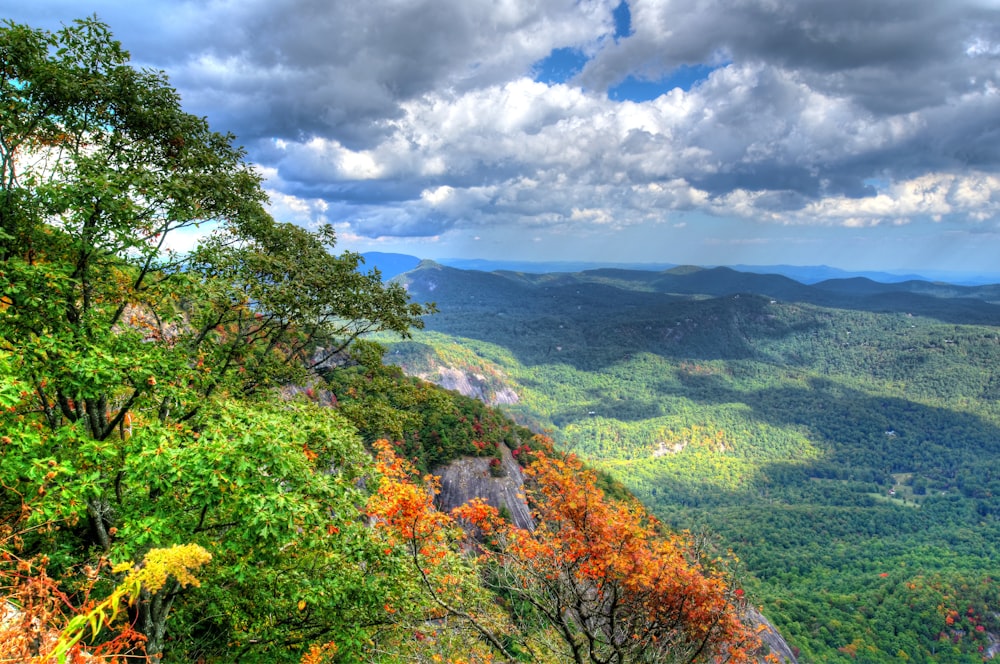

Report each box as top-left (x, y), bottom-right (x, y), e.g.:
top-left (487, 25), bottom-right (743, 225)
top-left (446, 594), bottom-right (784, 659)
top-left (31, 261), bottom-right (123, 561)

top-left (434, 444), bottom-right (535, 530)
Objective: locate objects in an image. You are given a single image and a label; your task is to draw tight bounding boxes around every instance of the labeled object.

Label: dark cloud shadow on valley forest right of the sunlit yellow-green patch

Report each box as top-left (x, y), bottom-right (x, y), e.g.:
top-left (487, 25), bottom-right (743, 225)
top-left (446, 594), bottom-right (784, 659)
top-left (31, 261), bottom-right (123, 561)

top-left (592, 379), bottom-right (1000, 586)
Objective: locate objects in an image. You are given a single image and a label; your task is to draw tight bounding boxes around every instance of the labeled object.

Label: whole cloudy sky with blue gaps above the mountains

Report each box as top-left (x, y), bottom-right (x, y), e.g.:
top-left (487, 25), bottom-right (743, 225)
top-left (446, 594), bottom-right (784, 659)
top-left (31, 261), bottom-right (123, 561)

top-left (0, 0), bottom-right (1000, 274)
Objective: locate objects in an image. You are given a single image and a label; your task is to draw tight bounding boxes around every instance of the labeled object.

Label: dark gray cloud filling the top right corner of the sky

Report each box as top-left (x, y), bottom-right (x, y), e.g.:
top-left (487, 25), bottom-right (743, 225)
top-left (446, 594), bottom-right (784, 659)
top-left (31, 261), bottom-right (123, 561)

top-left (581, 0), bottom-right (1000, 114)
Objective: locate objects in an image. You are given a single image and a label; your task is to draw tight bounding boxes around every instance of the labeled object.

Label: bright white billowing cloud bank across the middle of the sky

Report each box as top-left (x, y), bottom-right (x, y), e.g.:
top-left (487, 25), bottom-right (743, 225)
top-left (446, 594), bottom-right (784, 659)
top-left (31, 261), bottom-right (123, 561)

top-left (256, 58), bottom-right (994, 234)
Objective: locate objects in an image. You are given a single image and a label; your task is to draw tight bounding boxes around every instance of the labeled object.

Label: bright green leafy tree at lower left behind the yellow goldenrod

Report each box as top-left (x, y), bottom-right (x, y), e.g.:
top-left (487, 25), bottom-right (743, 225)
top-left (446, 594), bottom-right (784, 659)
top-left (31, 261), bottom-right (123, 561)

top-left (0, 352), bottom-right (395, 662)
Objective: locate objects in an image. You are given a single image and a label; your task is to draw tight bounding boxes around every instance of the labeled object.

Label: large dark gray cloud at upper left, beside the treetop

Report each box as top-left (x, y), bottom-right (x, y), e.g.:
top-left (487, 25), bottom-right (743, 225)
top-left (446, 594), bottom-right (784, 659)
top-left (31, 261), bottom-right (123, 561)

top-left (158, 0), bottom-right (603, 147)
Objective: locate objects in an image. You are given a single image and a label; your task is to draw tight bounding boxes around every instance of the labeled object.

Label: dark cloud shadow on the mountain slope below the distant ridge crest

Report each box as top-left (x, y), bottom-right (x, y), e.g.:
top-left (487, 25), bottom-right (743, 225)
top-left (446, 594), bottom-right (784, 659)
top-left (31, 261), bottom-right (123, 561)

top-left (425, 291), bottom-right (828, 371)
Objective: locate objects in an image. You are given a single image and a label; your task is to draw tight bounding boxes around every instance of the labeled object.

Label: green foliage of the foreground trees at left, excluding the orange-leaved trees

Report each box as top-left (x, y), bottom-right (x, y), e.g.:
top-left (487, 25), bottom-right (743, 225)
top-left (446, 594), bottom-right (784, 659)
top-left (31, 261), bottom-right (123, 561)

top-left (7, 19), bottom-right (680, 662)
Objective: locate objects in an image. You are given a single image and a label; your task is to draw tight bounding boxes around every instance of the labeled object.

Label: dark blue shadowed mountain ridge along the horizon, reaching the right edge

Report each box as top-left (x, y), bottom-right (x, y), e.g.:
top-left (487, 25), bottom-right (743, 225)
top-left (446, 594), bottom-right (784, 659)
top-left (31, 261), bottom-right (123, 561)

top-left (408, 268), bottom-right (1000, 370)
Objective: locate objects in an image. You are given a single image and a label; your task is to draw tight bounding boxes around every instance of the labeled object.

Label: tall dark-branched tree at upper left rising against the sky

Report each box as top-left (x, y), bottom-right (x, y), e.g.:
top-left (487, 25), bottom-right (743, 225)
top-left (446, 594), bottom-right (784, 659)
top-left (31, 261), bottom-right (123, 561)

top-left (0, 19), bottom-right (263, 439)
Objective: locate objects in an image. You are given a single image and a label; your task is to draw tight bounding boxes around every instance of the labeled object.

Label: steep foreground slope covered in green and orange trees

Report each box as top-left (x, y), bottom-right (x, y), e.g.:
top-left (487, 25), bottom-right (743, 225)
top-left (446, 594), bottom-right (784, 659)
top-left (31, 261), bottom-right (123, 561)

top-left (0, 19), bottom-right (775, 664)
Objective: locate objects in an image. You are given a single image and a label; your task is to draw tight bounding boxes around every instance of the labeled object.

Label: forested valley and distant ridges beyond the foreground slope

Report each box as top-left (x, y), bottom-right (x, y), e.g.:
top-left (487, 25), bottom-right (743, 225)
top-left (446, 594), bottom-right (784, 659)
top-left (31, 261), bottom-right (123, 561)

top-left (389, 263), bottom-right (1000, 662)
